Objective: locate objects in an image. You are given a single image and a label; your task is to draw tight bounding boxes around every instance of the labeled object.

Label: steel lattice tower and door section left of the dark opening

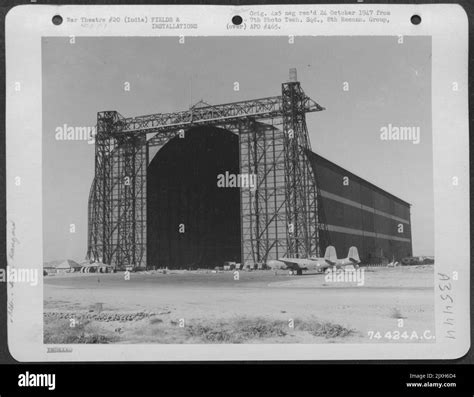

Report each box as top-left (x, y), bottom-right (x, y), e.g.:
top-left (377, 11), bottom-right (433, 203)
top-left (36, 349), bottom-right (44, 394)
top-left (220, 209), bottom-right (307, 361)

top-left (87, 111), bottom-right (147, 268)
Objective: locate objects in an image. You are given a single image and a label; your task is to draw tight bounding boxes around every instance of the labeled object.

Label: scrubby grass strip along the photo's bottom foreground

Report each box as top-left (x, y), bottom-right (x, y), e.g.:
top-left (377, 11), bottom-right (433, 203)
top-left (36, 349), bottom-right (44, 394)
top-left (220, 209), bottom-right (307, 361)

top-left (44, 317), bottom-right (355, 344)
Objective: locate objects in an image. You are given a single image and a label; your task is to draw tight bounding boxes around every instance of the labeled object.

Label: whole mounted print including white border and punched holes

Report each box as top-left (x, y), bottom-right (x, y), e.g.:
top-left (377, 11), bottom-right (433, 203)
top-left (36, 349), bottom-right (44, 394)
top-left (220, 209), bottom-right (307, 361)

top-left (3, 4), bottom-right (470, 366)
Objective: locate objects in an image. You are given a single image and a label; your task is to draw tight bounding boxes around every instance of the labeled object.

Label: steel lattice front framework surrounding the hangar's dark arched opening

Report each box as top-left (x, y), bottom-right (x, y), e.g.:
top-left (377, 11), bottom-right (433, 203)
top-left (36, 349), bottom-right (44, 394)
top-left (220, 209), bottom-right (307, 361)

top-left (87, 70), bottom-right (329, 268)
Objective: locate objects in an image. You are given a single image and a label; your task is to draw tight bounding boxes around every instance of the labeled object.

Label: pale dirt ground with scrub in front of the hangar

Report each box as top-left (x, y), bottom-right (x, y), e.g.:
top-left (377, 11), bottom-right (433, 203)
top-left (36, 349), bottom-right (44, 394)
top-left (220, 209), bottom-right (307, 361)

top-left (44, 265), bottom-right (435, 343)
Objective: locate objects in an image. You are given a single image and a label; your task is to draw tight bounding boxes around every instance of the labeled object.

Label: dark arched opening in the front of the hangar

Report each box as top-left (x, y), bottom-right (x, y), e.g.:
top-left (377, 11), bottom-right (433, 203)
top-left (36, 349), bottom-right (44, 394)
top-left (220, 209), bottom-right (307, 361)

top-left (147, 126), bottom-right (241, 269)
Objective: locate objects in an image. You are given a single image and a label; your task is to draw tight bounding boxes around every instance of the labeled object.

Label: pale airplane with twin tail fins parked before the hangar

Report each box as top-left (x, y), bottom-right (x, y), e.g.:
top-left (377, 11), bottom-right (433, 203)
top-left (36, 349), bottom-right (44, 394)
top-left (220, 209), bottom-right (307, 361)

top-left (267, 245), bottom-right (360, 276)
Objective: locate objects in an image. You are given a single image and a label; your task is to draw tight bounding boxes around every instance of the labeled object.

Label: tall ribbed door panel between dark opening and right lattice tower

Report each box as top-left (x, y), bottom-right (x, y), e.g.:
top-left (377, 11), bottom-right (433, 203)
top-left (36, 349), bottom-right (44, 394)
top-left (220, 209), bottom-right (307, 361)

top-left (239, 120), bottom-right (286, 265)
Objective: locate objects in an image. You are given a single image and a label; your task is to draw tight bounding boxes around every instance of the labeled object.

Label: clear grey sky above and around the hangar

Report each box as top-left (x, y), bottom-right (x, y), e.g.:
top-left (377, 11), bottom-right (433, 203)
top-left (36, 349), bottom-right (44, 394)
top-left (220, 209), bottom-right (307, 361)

top-left (42, 36), bottom-right (434, 262)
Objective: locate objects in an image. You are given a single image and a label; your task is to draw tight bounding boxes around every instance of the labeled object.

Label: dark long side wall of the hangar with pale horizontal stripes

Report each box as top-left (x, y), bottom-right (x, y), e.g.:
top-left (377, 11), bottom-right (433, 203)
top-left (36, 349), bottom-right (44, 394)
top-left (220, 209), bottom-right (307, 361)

top-left (308, 152), bottom-right (412, 263)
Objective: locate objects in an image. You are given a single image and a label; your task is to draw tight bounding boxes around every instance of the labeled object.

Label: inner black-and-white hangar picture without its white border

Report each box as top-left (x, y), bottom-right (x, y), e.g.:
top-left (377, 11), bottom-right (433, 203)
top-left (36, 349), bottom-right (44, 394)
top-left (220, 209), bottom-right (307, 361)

top-left (42, 36), bottom-right (435, 343)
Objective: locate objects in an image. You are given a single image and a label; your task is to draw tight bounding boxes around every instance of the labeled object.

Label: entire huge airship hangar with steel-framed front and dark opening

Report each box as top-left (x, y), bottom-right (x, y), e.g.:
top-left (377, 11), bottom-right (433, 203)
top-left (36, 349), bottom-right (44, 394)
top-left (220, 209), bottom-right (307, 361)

top-left (87, 70), bottom-right (412, 269)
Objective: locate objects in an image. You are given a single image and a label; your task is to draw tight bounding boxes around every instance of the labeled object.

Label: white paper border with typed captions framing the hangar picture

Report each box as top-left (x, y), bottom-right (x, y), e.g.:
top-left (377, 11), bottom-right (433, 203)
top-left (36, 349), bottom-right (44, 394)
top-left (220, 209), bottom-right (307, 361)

top-left (6, 4), bottom-right (470, 362)
